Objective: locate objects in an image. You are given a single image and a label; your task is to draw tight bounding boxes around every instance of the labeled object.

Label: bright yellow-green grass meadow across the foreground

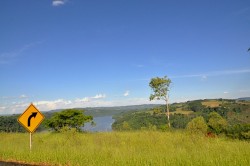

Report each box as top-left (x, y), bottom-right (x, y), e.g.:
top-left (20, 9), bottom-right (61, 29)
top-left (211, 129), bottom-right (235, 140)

top-left (0, 131), bottom-right (250, 166)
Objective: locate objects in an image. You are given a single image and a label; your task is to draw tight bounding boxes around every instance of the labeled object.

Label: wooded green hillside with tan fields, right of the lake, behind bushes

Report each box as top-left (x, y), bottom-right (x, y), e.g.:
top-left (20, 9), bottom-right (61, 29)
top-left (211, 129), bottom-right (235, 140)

top-left (112, 99), bottom-right (250, 134)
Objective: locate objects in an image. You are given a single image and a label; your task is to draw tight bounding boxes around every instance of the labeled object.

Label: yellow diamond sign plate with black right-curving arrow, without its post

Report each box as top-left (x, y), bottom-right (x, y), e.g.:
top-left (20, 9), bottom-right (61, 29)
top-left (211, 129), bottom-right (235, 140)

top-left (17, 103), bottom-right (44, 133)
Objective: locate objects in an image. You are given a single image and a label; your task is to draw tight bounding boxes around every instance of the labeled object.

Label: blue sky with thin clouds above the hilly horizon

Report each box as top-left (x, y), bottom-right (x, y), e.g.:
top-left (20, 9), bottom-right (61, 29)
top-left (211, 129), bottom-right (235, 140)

top-left (0, 0), bottom-right (250, 114)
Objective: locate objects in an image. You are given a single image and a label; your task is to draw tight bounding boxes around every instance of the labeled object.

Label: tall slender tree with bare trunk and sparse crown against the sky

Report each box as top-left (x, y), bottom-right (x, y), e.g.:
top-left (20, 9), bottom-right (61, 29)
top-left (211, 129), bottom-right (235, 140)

top-left (149, 76), bottom-right (171, 127)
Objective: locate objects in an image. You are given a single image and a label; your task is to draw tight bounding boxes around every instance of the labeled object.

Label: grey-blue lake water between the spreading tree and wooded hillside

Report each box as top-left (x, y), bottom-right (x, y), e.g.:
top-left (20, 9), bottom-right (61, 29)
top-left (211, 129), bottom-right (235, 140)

top-left (83, 116), bottom-right (115, 132)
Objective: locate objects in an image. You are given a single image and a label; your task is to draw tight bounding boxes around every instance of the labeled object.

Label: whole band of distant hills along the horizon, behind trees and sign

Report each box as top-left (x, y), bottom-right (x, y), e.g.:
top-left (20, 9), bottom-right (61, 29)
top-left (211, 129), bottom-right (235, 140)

top-left (0, 97), bottom-right (250, 132)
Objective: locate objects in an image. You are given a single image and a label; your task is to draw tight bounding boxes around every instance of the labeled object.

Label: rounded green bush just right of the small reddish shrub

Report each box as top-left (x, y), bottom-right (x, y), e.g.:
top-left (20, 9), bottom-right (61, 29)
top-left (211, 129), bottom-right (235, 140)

top-left (208, 112), bottom-right (227, 134)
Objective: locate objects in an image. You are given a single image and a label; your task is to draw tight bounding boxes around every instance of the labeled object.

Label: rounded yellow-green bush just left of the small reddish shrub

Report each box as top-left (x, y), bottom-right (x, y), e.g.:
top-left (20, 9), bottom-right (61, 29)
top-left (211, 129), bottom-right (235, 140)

top-left (187, 116), bottom-right (208, 134)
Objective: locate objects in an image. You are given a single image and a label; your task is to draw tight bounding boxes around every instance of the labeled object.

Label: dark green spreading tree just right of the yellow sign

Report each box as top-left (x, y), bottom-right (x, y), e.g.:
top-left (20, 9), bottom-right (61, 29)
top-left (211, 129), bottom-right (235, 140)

top-left (46, 109), bottom-right (93, 131)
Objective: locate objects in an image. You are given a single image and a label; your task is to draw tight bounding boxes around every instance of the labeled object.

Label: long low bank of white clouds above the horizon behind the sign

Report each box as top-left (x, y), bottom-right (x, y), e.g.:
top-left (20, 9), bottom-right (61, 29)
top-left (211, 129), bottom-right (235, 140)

top-left (0, 95), bottom-right (166, 114)
